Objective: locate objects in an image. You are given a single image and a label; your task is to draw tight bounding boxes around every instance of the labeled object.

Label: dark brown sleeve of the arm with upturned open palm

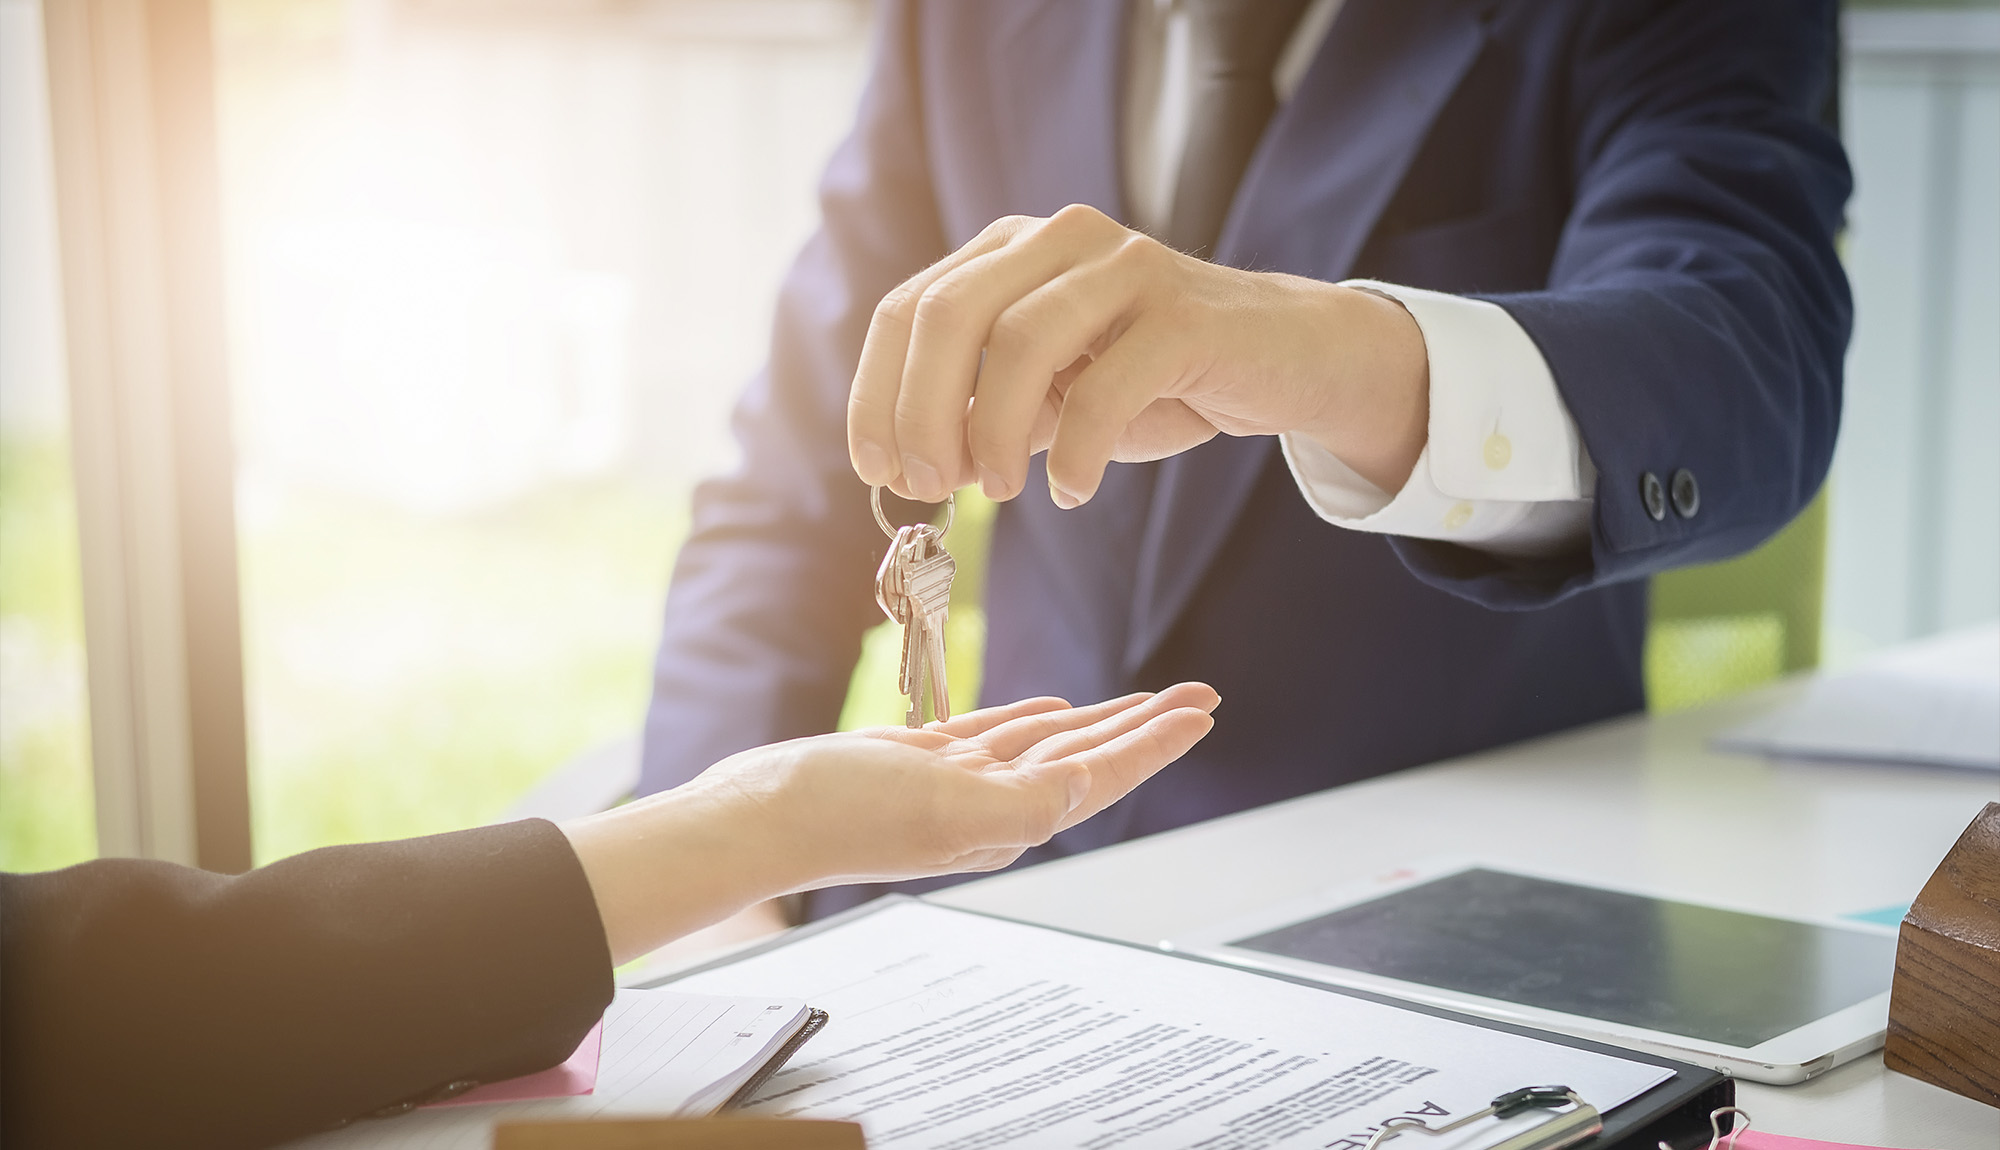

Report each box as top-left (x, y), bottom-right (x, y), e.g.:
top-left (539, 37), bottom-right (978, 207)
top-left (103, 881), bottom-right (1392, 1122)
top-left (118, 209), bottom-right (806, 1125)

top-left (0, 820), bottom-right (612, 1150)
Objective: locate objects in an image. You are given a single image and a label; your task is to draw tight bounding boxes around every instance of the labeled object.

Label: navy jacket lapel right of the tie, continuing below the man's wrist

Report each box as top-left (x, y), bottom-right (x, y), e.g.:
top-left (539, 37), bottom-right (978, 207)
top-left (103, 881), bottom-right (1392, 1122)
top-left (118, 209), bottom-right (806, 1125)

top-left (1114, 0), bottom-right (1484, 674)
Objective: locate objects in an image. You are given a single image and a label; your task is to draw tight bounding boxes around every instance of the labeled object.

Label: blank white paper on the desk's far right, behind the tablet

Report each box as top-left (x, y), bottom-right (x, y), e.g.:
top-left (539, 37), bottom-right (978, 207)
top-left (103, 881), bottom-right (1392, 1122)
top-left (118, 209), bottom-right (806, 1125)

top-left (1714, 624), bottom-right (2000, 770)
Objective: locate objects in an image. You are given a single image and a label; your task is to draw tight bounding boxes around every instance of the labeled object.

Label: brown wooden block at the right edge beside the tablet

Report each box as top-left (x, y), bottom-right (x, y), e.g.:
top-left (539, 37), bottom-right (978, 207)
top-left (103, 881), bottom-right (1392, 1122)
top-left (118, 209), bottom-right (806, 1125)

top-left (1882, 802), bottom-right (2000, 1106)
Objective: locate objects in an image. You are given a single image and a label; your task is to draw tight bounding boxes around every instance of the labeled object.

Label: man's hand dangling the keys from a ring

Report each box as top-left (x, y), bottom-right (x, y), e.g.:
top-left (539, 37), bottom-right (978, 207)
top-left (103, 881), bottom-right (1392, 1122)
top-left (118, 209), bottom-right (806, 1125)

top-left (848, 206), bottom-right (1430, 508)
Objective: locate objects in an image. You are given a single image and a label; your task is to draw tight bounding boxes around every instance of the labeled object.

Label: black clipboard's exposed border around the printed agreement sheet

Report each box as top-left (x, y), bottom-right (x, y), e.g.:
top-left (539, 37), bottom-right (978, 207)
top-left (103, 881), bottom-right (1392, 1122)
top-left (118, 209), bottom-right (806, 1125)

top-left (650, 896), bottom-right (1736, 1150)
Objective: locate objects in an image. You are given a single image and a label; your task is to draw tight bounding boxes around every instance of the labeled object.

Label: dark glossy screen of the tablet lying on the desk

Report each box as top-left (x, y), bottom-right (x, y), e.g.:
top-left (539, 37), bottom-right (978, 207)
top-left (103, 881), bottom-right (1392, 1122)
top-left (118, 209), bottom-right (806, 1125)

top-left (1230, 870), bottom-right (1896, 1046)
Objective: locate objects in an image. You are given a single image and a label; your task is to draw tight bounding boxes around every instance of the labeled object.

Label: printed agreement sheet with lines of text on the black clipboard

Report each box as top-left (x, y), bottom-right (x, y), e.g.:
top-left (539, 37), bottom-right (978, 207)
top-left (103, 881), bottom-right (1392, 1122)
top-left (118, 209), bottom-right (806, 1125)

top-left (674, 902), bottom-right (1672, 1150)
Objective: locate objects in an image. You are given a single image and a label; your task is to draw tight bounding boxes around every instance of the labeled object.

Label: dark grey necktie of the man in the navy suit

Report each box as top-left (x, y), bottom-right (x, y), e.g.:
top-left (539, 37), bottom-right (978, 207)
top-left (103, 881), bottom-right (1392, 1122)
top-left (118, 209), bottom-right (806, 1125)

top-left (1142, 0), bottom-right (1308, 256)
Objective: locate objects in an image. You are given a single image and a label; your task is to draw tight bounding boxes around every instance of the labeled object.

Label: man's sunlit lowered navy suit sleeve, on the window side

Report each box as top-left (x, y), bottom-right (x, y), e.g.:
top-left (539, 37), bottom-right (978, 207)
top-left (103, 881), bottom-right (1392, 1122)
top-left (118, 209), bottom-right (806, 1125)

top-left (640, 4), bottom-right (946, 794)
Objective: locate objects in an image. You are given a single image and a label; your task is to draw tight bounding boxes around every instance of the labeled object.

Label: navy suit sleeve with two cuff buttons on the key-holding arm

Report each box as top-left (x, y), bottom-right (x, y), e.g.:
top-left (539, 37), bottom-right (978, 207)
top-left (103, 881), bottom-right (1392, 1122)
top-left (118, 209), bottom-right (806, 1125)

top-left (1392, 0), bottom-right (1852, 610)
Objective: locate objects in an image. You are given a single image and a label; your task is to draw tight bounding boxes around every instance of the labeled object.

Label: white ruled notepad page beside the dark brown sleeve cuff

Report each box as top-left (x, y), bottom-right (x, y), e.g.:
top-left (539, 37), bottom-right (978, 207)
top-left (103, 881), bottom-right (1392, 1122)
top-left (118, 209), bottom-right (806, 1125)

top-left (290, 986), bottom-right (806, 1150)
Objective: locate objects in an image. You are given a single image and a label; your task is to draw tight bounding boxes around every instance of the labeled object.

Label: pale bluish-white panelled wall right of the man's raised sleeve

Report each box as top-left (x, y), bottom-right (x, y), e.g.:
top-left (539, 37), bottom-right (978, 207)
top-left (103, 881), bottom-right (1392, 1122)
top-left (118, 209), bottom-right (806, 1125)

top-left (1826, 8), bottom-right (2000, 662)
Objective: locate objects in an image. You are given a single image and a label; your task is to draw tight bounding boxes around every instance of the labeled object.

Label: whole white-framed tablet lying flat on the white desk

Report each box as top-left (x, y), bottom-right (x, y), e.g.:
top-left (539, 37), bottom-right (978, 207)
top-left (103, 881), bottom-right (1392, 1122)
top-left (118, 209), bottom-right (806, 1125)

top-left (1168, 862), bottom-right (1896, 1084)
